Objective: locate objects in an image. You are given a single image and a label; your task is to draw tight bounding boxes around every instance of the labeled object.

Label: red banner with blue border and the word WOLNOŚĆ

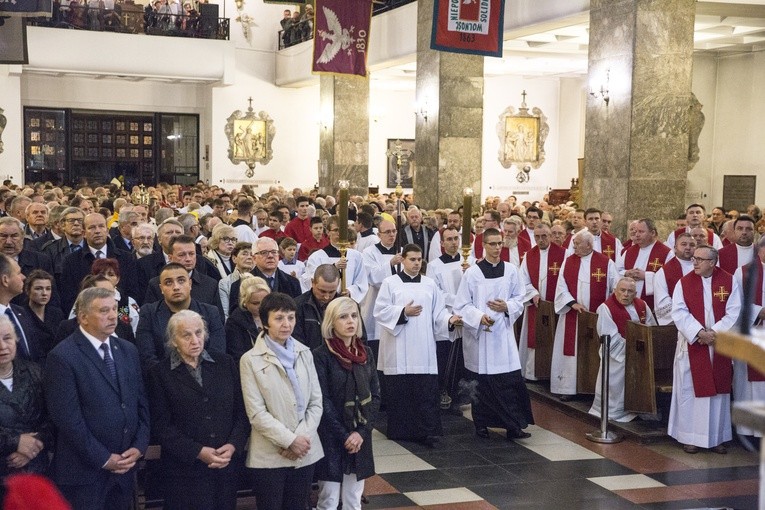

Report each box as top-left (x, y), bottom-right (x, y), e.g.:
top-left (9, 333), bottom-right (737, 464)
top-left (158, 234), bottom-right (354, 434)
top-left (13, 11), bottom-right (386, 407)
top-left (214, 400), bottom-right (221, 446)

top-left (430, 0), bottom-right (505, 57)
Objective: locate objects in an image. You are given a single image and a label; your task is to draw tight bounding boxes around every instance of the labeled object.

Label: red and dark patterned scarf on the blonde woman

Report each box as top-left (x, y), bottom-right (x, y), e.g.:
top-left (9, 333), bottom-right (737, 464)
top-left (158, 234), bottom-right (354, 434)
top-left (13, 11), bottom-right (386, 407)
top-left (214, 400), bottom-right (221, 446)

top-left (325, 336), bottom-right (372, 430)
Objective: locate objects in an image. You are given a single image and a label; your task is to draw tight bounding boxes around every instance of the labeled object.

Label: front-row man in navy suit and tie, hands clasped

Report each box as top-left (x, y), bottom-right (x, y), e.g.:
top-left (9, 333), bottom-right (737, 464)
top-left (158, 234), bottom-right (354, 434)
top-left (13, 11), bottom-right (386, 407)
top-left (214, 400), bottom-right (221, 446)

top-left (44, 286), bottom-right (149, 510)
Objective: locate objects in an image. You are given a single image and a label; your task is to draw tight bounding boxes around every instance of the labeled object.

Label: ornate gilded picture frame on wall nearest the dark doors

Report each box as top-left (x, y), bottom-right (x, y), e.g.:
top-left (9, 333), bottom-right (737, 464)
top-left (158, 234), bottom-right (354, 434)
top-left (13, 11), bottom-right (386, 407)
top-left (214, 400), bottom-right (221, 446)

top-left (225, 106), bottom-right (276, 177)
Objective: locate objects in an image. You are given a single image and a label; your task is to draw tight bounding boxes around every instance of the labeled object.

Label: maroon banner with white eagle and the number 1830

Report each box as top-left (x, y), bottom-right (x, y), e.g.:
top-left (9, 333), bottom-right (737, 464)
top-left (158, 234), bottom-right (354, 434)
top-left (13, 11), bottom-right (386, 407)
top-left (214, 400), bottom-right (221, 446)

top-left (313, 0), bottom-right (372, 76)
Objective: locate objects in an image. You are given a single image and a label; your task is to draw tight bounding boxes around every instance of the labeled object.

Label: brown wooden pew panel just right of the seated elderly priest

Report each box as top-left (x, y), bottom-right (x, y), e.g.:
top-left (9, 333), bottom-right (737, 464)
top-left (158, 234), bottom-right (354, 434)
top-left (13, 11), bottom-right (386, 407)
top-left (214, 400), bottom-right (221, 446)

top-left (624, 321), bottom-right (677, 414)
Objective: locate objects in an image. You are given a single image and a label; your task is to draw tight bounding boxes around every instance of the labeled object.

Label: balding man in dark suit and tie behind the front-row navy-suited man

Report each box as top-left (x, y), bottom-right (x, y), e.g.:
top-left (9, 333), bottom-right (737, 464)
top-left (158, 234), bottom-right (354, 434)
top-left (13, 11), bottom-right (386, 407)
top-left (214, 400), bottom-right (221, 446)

top-left (57, 213), bottom-right (142, 311)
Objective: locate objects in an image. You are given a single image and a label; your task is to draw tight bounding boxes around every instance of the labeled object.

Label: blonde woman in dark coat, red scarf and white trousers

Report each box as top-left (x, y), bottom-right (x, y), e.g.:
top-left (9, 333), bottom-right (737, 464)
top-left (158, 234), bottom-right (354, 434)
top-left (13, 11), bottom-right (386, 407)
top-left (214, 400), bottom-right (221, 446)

top-left (313, 297), bottom-right (380, 510)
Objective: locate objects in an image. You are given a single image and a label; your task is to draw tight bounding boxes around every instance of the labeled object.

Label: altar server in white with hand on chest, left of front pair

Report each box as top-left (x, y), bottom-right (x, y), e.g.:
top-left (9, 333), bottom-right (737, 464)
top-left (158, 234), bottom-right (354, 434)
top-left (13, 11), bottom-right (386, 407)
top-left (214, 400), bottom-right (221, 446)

top-left (374, 244), bottom-right (460, 446)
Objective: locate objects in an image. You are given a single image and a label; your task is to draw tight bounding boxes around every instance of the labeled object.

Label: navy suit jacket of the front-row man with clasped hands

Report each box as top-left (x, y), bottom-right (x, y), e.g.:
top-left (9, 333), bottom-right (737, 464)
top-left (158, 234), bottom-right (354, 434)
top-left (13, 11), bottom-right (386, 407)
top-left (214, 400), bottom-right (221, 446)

top-left (44, 329), bottom-right (150, 497)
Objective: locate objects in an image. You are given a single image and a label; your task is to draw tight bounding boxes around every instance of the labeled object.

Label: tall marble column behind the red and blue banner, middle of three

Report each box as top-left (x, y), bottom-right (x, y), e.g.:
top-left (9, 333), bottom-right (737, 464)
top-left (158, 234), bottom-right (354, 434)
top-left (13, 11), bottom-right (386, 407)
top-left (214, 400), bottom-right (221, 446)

top-left (414, 0), bottom-right (483, 209)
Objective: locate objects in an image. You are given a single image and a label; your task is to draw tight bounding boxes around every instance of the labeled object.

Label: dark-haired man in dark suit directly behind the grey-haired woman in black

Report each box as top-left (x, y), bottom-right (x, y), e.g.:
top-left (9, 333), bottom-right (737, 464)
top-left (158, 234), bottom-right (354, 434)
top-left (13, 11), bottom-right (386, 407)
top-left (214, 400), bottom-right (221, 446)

top-left (135, 264), bottom-right (226, 374)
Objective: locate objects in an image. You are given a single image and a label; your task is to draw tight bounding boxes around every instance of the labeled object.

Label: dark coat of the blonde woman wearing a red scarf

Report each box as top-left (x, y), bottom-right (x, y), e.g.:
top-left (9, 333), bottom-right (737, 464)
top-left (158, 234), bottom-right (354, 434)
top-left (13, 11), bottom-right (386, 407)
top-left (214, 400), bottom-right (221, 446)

top-left (313, 344), bottom-right (380, 482)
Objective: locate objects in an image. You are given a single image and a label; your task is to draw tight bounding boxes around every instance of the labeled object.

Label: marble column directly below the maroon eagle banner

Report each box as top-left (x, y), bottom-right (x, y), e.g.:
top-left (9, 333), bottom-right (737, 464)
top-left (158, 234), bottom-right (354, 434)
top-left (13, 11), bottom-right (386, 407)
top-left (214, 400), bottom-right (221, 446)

top-left (319, 75), bottom-right (369, 195)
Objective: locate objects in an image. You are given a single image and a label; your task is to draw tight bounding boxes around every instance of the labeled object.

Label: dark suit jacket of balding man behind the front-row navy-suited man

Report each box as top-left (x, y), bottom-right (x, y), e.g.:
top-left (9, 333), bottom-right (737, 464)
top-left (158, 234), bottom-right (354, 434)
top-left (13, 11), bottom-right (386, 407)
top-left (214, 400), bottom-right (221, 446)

top-left (57, 239), bottom-right (143, 313)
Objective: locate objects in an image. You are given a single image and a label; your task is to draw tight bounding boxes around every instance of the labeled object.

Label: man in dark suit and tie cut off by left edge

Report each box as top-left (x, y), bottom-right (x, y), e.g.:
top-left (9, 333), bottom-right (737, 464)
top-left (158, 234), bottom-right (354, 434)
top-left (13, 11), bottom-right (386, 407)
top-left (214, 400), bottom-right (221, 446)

top-left (0, 253), bottom-right (46, 362)
